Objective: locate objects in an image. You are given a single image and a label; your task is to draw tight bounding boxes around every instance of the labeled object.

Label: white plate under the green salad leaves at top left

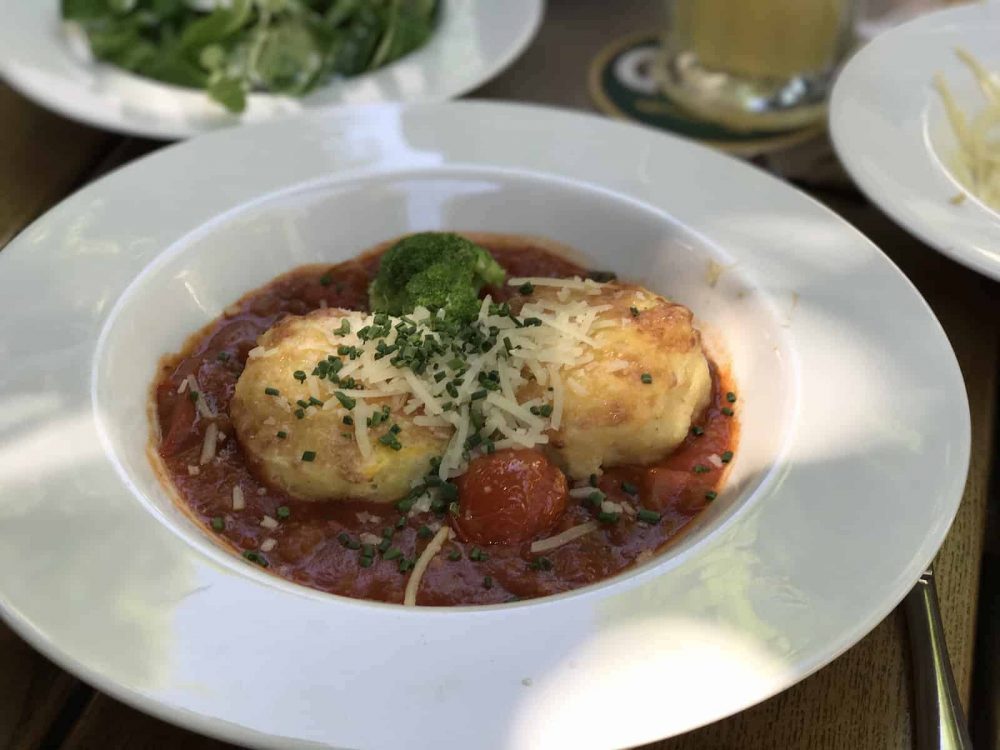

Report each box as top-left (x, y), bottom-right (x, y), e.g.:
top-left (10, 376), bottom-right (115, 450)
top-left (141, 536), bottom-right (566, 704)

top-left (0, 0), bottom-right (545, 139)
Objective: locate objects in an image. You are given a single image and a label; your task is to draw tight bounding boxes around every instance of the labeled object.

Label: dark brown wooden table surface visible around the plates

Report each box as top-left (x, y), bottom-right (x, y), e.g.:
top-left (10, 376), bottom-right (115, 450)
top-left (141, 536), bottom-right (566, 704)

top-left (0, 0), bottom-right (1000, 750)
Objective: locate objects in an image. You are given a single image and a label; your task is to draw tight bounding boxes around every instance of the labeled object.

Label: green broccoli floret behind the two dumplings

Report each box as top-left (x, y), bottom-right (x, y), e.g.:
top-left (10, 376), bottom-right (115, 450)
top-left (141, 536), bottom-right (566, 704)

top-left (368, 232), bottom-right (506, 320)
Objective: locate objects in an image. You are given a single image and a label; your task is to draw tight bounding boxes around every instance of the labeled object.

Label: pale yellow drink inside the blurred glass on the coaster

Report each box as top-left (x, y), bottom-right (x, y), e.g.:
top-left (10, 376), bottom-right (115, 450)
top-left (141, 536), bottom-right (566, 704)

top-left (668, 0), bottom-right (851, 78)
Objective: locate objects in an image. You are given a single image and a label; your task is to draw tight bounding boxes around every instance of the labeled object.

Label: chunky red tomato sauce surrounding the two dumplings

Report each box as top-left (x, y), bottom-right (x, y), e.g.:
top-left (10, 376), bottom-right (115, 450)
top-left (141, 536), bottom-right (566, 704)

top-left (153, 237), bottom-right (736, 605)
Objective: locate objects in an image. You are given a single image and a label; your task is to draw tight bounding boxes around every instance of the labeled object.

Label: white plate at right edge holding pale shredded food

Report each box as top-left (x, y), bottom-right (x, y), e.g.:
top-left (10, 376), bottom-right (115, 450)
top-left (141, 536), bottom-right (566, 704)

top-left (830, 2), bottom-right (1000, 280)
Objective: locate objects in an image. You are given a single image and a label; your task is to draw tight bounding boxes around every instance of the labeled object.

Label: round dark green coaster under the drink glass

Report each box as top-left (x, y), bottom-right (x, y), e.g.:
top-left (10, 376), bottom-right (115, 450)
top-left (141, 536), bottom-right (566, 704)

top-left (589, 32), bottom-right (826, 157)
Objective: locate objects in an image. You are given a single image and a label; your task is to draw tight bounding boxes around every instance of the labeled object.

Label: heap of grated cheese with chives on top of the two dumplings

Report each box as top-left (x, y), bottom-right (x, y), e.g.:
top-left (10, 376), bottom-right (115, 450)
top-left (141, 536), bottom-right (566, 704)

top-left (286, 278), bottom-right (610, 479)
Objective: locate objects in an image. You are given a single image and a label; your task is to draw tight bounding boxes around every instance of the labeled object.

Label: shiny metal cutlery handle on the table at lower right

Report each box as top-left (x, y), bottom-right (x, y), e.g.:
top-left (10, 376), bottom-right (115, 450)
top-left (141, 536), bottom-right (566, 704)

top-left (903, 568), bottom-right (972, 750)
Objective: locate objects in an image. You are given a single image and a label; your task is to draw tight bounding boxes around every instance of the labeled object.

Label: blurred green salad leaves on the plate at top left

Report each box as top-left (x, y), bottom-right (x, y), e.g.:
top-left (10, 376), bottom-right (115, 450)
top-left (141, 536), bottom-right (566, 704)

top-left (62, 0), bottom-right (437, 112)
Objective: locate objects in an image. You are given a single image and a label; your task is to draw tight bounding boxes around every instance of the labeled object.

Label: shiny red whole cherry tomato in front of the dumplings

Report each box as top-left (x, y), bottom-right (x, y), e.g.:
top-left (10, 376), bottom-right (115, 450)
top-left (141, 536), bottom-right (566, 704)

top-left (451, 450), bottom-right (569, 544)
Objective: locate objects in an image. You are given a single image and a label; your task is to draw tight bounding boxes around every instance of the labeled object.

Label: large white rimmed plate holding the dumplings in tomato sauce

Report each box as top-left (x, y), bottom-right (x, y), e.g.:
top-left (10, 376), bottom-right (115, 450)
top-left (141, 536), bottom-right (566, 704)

top-left (0, 102), bottom-right (969, 749)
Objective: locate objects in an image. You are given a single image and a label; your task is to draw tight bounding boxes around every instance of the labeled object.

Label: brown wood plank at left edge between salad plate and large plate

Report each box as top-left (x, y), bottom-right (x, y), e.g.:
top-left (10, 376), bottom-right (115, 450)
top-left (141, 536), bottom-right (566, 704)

top-left (0, 84), bottom-right (118, 248)
